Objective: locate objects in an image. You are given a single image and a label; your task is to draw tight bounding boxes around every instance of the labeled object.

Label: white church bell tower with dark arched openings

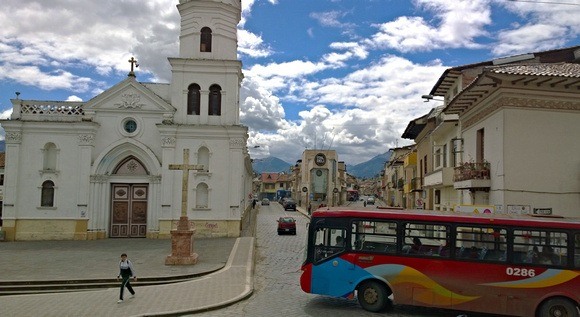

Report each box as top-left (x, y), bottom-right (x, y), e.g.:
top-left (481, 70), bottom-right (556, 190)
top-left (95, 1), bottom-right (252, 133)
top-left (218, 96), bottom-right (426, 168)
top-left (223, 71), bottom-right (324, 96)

top-left (169, 0), bottom-right (243, 125)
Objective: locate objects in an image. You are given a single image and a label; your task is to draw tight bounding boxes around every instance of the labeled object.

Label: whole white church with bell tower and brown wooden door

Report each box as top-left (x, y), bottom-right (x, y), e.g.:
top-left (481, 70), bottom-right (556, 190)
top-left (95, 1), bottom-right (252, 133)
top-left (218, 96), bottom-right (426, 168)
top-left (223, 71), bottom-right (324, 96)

top-left (0, 0), bottom-right (252, 241)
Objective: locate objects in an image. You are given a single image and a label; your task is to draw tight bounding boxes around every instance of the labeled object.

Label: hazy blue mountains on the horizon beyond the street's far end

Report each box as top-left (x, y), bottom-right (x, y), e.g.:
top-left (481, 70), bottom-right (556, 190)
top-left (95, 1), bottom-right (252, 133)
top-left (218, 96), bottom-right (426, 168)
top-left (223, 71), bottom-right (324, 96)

top-left (252, 152), bottom-right (391, 179)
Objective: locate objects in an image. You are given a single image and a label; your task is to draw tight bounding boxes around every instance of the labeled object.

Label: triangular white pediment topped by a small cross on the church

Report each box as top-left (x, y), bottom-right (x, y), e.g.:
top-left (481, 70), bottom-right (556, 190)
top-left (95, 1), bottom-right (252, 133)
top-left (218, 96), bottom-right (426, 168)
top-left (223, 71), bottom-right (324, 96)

top-left (84, 77), bottom-right (175, 113)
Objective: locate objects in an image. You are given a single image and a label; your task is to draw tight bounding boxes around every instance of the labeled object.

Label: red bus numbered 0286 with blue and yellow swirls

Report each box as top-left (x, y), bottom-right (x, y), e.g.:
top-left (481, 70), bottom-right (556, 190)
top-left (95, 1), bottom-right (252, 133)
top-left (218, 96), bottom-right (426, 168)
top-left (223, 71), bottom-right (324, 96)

top-left (300, 208), bottom-right (580, 317)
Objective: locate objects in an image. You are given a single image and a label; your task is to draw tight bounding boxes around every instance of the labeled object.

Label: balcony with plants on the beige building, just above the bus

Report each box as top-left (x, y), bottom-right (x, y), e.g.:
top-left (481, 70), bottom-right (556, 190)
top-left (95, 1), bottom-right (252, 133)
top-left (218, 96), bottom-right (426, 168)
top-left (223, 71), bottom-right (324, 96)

top-left (453, 162), bottom-right (491, 190)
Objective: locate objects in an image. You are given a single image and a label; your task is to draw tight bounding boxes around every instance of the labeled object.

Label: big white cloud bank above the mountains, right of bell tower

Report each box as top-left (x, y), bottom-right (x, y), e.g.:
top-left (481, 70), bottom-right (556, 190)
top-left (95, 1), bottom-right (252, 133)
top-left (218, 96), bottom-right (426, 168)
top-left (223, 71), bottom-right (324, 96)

top-left (246, 56), bottom-right (445, 164)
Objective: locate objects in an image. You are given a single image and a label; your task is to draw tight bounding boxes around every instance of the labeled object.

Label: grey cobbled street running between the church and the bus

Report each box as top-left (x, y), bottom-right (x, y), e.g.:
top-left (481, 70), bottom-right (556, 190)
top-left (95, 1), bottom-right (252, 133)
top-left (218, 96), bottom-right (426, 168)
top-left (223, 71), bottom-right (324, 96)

top-left (190, 201), bottom-right (492, 317)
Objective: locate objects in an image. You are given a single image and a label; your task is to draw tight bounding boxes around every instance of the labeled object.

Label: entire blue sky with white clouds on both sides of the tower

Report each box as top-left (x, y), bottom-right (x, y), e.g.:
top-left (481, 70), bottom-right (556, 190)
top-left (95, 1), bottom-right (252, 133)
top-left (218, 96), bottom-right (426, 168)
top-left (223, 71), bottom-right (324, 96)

top-left (0, 0), bottom-right (580, 163)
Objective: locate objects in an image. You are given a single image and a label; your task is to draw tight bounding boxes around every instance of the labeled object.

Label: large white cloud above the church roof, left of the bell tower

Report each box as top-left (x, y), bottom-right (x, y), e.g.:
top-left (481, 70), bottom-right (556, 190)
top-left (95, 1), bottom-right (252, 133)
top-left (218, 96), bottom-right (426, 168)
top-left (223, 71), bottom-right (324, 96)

top-left (0, 0), bottom-right (179, 89)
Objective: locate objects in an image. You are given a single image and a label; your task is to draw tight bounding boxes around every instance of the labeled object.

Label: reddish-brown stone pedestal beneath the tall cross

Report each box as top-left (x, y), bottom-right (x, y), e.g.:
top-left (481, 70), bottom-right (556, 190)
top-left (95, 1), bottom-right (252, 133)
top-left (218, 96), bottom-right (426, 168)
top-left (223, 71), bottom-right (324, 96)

top-left (165, 216), bottom-right (197, 265)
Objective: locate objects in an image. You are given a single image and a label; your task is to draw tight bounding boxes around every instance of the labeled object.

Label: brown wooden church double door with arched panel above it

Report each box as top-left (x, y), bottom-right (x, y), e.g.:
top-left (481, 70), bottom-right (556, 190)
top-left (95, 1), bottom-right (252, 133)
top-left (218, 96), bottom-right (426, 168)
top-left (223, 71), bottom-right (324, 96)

top-left (110, 156), bottom-right (149, 238)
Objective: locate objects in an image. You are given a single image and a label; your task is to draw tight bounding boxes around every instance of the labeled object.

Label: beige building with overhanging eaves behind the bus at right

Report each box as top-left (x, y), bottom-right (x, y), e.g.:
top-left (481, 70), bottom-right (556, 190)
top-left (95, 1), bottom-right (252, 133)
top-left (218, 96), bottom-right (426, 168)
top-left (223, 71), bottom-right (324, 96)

top-left (409, 46), bottom-right (580, 216)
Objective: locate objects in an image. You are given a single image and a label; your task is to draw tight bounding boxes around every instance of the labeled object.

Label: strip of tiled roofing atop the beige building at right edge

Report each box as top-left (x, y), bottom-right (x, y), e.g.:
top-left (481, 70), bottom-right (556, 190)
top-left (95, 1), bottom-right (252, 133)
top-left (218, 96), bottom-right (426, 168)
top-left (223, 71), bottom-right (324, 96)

top-left (490, 63), bottom-right (580, 78)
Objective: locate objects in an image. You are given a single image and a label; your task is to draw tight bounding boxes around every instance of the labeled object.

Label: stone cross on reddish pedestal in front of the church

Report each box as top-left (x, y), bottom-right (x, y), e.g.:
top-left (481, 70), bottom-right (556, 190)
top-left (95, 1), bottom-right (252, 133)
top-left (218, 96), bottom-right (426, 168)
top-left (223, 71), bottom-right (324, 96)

top-left (165, 149), bottom-right (203, 265)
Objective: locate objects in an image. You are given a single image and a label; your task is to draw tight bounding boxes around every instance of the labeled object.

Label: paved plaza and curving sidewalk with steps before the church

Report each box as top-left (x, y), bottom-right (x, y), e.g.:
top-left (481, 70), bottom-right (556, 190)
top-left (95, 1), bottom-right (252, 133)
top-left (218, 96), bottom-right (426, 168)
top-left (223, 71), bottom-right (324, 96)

top-left (0, 237), bottom-right (254, 317)
